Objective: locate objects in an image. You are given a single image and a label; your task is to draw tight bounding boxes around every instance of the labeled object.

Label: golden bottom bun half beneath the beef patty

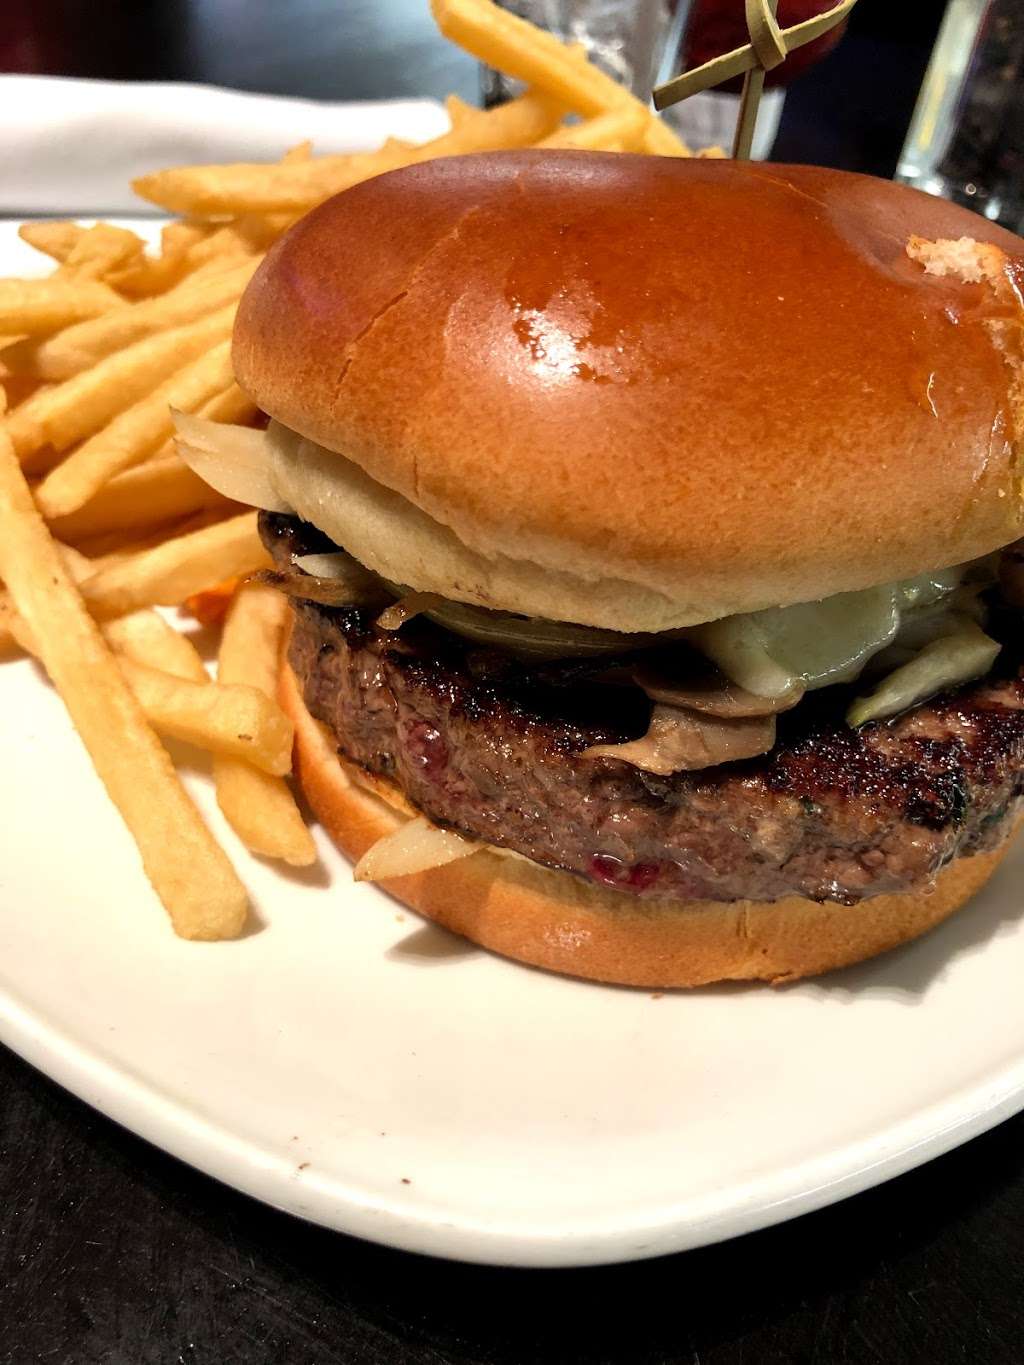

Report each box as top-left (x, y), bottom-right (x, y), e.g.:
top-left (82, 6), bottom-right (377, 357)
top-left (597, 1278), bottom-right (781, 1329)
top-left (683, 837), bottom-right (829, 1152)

top-left (281, 665), bottom-right (1010, 987)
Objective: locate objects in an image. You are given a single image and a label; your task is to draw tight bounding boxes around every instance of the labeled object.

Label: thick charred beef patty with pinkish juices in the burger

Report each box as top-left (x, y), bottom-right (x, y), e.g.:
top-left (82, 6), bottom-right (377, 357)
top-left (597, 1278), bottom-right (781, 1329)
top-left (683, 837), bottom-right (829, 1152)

top-left (261, 513), bottom-right (1024, 904)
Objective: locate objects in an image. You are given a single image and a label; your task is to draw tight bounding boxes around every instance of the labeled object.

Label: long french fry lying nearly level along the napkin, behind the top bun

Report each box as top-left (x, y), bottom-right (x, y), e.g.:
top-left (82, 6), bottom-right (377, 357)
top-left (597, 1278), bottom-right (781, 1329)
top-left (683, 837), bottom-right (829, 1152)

top-left (134, 91), bottom-right (565, 216)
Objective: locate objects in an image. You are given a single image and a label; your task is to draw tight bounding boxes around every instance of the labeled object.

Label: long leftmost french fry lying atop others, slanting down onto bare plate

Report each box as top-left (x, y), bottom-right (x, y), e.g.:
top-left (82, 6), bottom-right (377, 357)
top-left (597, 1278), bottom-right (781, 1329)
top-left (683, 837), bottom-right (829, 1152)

top-left (0, 427), bottom-right (247, 939)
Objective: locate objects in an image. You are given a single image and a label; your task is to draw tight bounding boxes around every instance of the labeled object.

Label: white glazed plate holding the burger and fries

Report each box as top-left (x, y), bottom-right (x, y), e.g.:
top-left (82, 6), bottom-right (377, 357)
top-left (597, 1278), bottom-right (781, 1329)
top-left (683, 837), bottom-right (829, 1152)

top-left (0, 218), bottom-right (1024, 1265)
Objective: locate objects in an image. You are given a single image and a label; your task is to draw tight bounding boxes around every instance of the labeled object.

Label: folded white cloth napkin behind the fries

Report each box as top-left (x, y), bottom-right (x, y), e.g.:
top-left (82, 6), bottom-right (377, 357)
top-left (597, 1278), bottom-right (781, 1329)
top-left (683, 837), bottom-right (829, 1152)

top-left (0, 76), bottom-right (448, 214)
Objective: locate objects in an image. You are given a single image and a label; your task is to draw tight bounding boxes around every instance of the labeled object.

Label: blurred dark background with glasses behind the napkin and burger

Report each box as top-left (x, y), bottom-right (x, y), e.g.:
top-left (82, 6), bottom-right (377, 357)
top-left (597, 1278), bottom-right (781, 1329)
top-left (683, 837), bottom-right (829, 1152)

top-left (0, 0), bottom-right (1024, 228)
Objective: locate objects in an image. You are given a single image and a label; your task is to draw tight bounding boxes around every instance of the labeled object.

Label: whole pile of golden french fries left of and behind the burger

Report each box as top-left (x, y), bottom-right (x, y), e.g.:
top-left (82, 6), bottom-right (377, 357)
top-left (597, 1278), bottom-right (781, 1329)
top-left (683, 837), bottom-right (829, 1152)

top-left (0, 0), bottom-right (704, 939)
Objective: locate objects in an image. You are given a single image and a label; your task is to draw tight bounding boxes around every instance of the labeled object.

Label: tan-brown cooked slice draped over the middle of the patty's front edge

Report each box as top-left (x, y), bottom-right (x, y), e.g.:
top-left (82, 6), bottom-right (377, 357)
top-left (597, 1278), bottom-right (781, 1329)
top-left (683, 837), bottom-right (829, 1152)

top-left (583, 703), bottom-right (776, 777)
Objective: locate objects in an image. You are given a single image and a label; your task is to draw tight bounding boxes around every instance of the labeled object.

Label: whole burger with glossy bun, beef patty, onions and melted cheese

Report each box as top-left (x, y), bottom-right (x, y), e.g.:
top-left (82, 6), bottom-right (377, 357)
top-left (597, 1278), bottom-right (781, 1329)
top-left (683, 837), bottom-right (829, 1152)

top-left (182, 152), bottom-right (1024, 987)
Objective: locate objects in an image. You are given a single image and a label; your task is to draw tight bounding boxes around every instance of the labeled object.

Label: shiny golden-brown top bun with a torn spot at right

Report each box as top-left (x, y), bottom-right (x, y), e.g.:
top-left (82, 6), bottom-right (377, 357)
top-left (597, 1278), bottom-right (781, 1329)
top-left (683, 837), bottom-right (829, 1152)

top-left (233, 152), bottom-right (1024, 631)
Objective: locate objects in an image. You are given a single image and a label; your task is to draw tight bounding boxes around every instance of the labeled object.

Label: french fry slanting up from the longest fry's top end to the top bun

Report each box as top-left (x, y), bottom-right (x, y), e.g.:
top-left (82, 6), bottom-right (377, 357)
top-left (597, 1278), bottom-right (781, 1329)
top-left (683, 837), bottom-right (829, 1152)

top-left (7, 303), bottom-right (235, 460)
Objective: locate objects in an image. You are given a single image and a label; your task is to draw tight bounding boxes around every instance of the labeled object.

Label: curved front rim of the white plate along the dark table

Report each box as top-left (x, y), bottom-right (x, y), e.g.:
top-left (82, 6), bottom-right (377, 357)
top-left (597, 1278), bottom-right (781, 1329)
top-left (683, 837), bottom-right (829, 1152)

top-left (0, 971), bottom-right (1024, 1269)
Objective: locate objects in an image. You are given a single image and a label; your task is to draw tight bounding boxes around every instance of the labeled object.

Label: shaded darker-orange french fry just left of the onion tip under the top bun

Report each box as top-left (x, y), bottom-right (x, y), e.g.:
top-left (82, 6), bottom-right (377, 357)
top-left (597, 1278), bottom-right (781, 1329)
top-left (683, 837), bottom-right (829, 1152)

top-left (51, 455), bottom-right (235, 543)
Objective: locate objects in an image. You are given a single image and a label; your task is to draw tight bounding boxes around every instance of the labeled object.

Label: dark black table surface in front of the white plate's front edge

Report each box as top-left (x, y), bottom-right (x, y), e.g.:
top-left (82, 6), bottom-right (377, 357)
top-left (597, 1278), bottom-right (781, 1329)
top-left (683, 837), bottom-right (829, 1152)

top-left (0, 1051), bottom-right (1024, 1365)
